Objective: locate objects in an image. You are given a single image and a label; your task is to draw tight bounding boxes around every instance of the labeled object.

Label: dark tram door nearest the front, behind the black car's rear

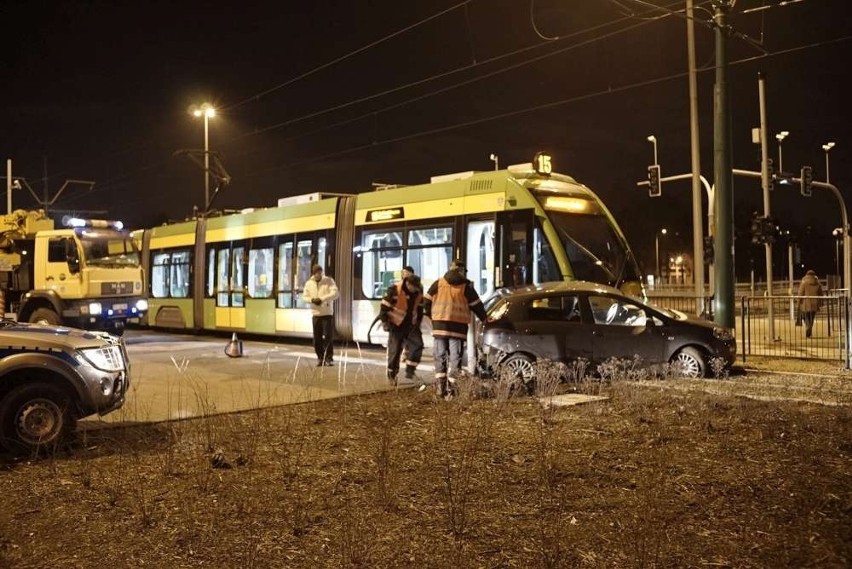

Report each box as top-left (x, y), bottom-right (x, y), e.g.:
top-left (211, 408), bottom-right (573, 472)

top-left (494, 209), bottom-right (535, 288)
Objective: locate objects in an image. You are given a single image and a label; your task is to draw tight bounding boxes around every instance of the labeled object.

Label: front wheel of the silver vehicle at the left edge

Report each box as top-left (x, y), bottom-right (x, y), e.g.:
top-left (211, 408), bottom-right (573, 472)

top-left (0, 382), bottom-right (76, 454)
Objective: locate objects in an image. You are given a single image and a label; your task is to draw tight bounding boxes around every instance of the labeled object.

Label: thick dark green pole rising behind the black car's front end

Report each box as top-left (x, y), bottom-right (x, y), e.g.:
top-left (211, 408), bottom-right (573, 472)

top-left (713, 0), bottom-right (734, 328)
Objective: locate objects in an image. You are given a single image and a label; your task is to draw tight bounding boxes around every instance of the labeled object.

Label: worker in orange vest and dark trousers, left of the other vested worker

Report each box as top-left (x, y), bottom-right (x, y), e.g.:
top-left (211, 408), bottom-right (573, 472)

top-left (379, 267), bottom-right (423, 385)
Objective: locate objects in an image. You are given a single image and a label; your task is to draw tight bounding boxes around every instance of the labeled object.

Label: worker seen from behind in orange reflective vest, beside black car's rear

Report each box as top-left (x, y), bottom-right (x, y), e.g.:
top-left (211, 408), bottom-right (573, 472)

top-left (423, 259), bottom-right (485, 398)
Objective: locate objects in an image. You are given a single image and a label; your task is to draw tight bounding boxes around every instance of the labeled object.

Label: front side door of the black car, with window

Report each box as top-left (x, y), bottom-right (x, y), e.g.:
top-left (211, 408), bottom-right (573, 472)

top-left (588, 295), bottom-right (665, 364)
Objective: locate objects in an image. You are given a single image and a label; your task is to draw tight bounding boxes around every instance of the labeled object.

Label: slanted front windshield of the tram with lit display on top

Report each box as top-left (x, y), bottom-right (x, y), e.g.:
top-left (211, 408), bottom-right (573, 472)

top-left (538, 195), bottom-right (640, 287)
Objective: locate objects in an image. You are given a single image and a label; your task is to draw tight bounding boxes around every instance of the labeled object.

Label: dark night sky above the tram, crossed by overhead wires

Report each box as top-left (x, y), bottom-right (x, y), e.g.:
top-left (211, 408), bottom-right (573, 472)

top-left (0, 0), bottom-right (852, 280)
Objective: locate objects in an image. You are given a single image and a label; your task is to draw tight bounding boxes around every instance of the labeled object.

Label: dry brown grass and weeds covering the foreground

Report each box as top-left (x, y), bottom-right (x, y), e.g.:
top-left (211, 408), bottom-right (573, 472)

top-left (0, 366), bottom-right (852, 568)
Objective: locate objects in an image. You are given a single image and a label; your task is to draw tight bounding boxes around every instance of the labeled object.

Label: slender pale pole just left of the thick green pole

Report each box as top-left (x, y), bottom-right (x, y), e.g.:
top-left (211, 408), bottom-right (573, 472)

top-left (686, 0), bottom-right (711, 302)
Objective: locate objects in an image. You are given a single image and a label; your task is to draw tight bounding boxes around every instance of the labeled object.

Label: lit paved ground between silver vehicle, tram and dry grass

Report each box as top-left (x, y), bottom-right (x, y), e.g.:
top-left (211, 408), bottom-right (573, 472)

top-left (95, 330), bottom-right (412, 422)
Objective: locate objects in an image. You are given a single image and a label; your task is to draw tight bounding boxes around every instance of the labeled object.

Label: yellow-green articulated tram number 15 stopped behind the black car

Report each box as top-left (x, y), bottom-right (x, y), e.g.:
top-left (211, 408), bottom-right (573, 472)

top-left (134, 153), bottom-right (643, 345)
